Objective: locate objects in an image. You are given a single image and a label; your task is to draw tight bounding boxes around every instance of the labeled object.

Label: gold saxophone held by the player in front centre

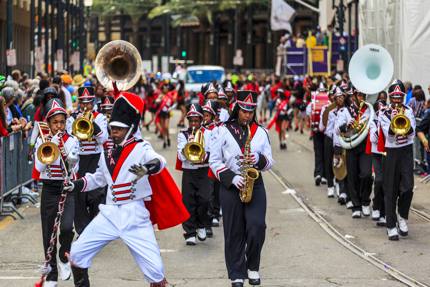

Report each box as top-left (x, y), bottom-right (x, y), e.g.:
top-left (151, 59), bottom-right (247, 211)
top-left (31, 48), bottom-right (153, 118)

top-left (239, 125), bottom-right (259, 203)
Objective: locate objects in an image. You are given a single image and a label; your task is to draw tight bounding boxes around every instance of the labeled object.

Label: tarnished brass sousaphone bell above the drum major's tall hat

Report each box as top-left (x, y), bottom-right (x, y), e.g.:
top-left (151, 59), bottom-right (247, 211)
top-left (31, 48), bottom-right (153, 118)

top-left (95, 40), bottom-right (142, 91)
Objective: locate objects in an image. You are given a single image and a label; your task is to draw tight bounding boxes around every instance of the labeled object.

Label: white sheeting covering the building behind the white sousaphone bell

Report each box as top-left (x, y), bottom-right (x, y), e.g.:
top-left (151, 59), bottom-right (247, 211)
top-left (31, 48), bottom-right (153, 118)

top-left (359, 0), bottom-right (430, 91)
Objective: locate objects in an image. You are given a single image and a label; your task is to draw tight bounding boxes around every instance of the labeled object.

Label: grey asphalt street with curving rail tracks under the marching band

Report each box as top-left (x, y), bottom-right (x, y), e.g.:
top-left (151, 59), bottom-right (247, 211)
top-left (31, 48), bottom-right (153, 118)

top-left (0, 114), bottom-right (424, 287)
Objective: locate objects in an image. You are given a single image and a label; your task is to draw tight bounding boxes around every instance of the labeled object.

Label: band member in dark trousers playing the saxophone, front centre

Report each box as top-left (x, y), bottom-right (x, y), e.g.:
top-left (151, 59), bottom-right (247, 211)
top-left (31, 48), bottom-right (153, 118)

top-left (209, 91), bottom-right (273, 287)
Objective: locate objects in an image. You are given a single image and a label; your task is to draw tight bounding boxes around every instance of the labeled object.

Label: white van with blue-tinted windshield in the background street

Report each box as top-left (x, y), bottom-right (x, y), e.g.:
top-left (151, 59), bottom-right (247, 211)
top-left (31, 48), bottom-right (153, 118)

top-left (185, 65), bottom-right (225, 93)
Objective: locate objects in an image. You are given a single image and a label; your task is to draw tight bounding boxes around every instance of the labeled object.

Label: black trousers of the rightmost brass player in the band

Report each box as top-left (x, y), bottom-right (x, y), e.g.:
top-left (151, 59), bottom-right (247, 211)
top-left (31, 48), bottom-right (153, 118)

top-left (384, 144), bottom-right (414, 228)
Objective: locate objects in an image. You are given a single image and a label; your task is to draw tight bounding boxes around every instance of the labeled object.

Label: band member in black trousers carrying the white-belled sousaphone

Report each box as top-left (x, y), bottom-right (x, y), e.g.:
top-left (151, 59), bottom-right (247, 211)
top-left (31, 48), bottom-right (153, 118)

top-left (335, 86), bottom-right (372, 218)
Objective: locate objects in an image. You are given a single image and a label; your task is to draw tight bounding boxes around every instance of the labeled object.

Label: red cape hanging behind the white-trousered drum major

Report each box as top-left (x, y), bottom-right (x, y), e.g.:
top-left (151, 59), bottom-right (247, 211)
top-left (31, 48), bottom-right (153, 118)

top-left (145, 168), bottom-right (190, 230)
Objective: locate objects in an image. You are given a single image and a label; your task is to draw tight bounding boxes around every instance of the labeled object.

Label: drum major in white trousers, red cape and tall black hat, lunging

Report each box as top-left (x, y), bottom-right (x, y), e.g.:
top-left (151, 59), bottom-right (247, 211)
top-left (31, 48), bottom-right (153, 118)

top-left (65, 92), bottom-right (188, 287)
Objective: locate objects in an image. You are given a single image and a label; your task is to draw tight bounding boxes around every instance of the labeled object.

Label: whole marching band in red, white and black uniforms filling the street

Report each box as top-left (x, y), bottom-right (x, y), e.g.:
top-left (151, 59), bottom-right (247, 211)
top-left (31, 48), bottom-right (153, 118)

top-left (2, 38), bottom-right (428, 287)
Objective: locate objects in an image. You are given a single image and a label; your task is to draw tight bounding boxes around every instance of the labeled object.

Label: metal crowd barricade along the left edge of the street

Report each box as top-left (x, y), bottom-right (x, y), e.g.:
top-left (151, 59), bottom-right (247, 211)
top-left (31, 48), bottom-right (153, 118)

top-left (0, 133), bottom-right (36, 219)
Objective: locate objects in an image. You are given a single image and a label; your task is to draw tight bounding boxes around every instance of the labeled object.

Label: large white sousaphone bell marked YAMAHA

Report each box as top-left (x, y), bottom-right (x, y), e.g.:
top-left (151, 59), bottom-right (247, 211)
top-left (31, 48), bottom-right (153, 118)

top-left (348, 44), bottom-right (394, 94)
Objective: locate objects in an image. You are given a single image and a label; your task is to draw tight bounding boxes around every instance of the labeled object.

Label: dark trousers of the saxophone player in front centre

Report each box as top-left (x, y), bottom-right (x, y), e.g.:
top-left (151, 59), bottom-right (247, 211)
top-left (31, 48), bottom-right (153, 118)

top-left (220, 180), bottom-right (266, 280)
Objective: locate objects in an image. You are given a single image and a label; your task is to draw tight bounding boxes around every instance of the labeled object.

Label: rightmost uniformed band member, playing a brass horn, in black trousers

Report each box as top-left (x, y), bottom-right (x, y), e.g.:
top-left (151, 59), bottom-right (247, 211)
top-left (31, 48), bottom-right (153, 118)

top-left (379, 80), bottom-right (416, 240)
